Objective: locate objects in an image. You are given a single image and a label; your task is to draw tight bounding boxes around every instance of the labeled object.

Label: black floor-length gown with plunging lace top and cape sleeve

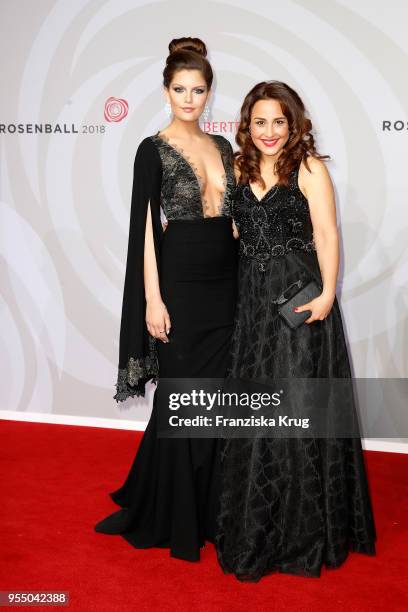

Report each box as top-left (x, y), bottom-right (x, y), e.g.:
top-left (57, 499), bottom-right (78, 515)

top-left (95, 134), bottom-right (238, 561)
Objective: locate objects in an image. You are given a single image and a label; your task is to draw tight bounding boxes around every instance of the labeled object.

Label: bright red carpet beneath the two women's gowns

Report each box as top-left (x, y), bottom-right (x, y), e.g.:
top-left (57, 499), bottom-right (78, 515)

top-left (0, 421), bottom-right (408, 612)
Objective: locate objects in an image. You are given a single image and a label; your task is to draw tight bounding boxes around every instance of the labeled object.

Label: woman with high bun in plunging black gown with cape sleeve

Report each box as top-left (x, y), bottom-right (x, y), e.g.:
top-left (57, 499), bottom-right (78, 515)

top-left (95, 38), bottom-right (237, 561)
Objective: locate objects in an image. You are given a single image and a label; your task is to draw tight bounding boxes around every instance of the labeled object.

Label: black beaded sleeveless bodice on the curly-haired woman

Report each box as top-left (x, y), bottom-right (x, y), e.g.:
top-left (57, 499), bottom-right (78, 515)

top-left (233, 169), bottom-right (316, 272)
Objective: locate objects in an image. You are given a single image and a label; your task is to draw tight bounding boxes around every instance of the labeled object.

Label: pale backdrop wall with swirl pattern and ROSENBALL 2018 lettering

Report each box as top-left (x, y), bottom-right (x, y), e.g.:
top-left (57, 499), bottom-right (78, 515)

top-left (0, 0), bottom-right (408, 430)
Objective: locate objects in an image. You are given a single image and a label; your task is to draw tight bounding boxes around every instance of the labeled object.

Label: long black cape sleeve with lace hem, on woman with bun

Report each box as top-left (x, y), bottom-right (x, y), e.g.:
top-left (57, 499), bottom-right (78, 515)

top-left (114, 137), bottom-right (163, 402)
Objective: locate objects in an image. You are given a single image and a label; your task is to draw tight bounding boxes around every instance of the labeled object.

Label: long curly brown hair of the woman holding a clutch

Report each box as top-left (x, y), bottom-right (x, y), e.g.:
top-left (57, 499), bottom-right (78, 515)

top-left (234, 81), bottom-right (330, 189)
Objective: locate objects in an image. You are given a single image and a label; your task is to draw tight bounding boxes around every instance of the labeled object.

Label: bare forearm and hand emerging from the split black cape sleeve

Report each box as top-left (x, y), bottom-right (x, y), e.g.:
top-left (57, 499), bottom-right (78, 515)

top-left (144, 202), bottom-right (171, 343)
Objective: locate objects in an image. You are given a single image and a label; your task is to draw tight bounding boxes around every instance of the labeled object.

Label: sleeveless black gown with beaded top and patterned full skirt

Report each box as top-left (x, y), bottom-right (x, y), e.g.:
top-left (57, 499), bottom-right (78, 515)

top-left (216, 165), bottom-right (376, 581)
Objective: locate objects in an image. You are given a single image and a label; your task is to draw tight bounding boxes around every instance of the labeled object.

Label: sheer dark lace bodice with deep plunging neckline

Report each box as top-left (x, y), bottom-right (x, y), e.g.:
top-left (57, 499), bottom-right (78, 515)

top-left (151, 133), bottom-right (235, 221)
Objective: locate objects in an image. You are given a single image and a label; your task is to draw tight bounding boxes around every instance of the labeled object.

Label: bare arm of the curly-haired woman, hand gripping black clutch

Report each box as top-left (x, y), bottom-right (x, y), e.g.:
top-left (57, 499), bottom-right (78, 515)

top-left (296, 157), bottom-right (339, 323)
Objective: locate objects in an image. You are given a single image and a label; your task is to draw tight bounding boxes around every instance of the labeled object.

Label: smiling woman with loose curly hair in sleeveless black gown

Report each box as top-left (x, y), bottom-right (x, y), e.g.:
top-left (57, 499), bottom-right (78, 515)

top-left (216, 81), bottom-right (376, 581)
